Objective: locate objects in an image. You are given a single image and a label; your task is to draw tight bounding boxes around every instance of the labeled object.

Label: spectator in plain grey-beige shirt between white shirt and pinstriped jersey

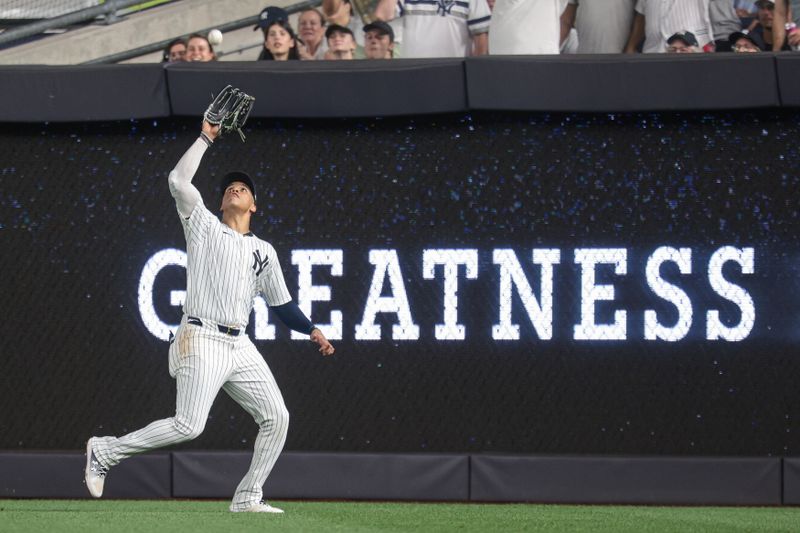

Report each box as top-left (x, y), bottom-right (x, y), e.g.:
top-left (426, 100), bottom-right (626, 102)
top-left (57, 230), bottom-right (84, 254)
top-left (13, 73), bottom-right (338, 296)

top-left (561, 0), bottom-right (636, 54)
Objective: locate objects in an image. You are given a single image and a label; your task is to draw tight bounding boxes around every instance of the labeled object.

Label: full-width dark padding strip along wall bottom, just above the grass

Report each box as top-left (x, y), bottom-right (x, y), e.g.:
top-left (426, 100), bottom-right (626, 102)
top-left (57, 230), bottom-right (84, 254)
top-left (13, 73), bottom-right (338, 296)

top-left (0, 451), bottom-right (800, 505)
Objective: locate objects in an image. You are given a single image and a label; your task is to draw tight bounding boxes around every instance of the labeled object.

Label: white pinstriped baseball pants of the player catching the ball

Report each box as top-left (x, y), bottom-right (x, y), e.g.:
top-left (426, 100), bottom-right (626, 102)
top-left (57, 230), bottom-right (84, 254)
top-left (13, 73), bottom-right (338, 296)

top-left (94, 317), bottom-right (289, 510)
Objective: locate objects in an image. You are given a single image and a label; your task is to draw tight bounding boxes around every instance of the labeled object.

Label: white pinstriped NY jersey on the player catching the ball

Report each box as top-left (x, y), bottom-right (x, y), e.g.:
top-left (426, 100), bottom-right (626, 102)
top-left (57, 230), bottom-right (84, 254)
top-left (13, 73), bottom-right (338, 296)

top-left (180, 202), bottom-right (292, 328)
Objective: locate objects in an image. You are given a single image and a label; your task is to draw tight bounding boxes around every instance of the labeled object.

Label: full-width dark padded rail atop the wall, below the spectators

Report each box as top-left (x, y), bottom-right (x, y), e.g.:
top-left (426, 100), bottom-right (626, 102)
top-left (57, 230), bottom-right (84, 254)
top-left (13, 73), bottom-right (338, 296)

top-left (0, 52), bottom-right (800, 122)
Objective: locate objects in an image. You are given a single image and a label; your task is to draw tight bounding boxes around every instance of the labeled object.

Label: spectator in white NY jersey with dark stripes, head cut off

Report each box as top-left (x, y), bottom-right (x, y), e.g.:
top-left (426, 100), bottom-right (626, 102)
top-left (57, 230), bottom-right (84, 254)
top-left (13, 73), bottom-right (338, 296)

top-left (374, 0), bottom-right (488, 57)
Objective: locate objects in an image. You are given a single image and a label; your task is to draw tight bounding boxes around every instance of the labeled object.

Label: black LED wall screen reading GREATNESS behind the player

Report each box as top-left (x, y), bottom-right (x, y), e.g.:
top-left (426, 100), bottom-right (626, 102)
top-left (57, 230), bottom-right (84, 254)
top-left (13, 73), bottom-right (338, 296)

top-left (0, 111), bottom-right (800, 455)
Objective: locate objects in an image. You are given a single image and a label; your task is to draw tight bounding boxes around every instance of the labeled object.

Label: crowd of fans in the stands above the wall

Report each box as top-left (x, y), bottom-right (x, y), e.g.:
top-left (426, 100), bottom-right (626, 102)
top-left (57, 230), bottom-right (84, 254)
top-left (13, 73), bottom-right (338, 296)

top-left (159, 0), bottom-right (800, 62)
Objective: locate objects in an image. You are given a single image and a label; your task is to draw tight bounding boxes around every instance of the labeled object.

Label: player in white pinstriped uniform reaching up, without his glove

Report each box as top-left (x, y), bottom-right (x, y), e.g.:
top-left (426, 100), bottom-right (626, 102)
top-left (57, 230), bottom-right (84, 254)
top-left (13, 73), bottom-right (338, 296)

top-left (85, 121), bottom-right (334, 513)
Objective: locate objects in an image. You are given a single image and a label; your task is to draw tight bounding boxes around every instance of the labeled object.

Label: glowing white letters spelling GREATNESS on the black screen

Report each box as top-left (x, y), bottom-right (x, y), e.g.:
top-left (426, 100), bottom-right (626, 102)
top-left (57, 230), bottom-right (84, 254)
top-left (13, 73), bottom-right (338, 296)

top-left (138, 246), bottom-right (755, 342)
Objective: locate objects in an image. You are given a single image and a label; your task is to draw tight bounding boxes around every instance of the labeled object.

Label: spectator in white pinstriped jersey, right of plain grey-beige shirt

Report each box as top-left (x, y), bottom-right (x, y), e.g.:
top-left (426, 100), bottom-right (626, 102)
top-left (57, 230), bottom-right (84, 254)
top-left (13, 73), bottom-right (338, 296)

top-left (625, 0), bottom-right (713, 54)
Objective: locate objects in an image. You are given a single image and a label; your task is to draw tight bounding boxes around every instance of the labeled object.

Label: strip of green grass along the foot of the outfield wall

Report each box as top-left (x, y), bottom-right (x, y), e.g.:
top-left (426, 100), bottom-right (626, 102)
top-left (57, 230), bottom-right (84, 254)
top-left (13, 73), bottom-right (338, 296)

top-left (0, 500), bottom-right (800, 533)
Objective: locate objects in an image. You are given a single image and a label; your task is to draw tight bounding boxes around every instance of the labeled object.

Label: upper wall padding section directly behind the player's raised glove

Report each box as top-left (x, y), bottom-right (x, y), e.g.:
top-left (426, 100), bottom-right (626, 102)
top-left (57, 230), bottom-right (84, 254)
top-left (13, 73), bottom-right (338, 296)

top-left (165, 59), bottom-right (467, 118)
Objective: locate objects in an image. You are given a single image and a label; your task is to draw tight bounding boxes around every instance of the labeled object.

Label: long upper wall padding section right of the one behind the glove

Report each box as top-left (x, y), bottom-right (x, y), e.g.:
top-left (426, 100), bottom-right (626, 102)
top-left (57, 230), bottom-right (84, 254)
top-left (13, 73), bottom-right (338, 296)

top-left (466, 54), bottom-right (780, 112)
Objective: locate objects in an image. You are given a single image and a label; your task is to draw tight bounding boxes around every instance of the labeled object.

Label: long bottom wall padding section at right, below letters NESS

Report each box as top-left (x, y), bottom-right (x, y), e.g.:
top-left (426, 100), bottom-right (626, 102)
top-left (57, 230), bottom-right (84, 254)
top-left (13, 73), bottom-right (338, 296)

top-left (470, 455), bottom-right (781, 505)
